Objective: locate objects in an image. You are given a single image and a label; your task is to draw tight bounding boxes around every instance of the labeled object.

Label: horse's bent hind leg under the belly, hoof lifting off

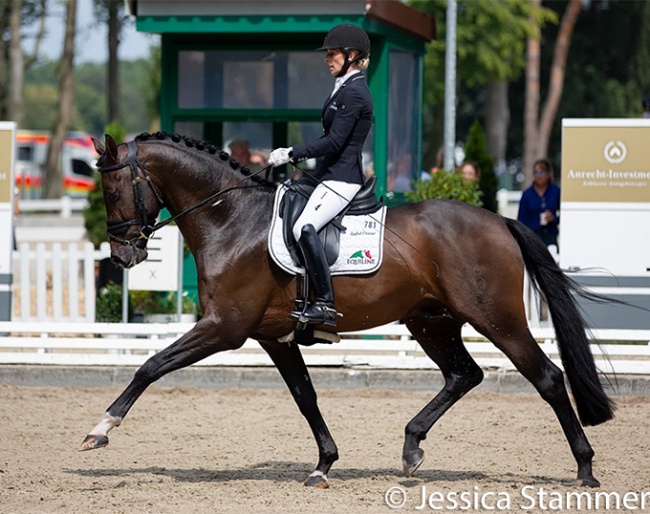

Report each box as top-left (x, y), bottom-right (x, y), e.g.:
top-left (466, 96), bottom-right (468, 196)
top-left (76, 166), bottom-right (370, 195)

top-left (402, 317), bottom-right (483, 476)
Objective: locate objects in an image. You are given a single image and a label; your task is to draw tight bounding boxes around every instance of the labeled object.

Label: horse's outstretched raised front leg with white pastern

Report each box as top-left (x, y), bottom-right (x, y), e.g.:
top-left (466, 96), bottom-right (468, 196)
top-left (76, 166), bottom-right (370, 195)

top-left (79, 318), bottom-right (246, 451)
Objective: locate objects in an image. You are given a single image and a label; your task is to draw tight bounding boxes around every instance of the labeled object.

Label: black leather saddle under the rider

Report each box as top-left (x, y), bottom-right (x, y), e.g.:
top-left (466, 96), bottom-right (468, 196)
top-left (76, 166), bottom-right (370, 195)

top-left (280, 177), bottom-right (384, 267)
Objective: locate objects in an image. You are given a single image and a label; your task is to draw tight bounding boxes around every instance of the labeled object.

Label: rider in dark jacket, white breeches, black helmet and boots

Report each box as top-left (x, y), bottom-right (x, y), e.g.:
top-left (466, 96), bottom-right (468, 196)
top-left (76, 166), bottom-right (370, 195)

top-left (269, 24), bottom-right (372, 327)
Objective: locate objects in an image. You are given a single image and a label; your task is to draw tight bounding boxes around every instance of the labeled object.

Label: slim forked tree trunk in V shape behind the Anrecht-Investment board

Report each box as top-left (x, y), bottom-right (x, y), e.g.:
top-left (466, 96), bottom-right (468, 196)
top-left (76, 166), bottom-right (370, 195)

top-left (523, 0), bottom-right (582, 184)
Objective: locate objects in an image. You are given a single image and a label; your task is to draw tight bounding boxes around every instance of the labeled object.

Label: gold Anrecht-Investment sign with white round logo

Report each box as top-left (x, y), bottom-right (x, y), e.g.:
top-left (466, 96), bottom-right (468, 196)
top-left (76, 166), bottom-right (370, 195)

top-left (562, 119), bottom-right (650, 203)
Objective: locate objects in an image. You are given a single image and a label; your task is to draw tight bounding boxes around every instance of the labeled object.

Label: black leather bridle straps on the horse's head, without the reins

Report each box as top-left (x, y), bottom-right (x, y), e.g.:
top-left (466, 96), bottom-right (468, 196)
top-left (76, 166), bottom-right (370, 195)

top-left (99, 141), bottom-right (165, 246)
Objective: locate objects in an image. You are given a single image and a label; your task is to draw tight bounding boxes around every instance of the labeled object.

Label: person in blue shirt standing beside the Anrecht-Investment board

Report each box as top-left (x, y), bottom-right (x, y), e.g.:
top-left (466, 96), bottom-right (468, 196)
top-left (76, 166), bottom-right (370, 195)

top-left (517, 159), bottom-right (560, 248)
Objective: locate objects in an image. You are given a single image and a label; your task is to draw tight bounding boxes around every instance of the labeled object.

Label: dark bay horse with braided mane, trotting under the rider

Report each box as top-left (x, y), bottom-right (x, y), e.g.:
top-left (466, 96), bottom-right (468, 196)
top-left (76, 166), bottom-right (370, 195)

top-left (80, 133), bottom-right (614, 488)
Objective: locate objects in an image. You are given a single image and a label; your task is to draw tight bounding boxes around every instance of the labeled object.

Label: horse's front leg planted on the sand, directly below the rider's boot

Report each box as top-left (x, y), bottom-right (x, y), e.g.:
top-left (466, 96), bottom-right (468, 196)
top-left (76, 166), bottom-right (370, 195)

top-left (260, 341), bottom-right (339, 489)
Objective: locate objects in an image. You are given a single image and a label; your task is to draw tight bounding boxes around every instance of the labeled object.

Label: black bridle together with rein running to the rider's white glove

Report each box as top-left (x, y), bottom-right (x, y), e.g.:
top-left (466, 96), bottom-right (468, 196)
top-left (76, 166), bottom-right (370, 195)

top-left (98, 140), bottom-right (271, 246)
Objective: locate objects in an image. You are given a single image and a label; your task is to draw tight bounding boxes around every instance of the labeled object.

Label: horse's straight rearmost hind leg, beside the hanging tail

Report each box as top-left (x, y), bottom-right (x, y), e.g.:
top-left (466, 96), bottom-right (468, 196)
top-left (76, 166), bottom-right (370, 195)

top-left (483, 327), bottom-right (600, 487)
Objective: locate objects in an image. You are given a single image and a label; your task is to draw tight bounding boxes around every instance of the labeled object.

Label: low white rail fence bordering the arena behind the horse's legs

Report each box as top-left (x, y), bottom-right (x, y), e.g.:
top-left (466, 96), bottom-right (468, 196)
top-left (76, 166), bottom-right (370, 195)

top-left (0, 322), bottom-right (650, 375)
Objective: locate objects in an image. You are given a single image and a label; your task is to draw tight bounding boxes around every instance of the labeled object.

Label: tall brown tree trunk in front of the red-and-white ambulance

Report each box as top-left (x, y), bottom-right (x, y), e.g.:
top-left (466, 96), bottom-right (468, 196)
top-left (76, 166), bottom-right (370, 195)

top-left (45, 0), bottom-right (77, 198)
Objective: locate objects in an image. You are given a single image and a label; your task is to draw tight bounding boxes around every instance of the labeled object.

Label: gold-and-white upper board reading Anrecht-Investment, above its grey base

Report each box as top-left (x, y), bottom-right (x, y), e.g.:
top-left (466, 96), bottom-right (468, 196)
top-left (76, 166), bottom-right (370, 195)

top-left (560, 119), bottom-right (650, 277)
